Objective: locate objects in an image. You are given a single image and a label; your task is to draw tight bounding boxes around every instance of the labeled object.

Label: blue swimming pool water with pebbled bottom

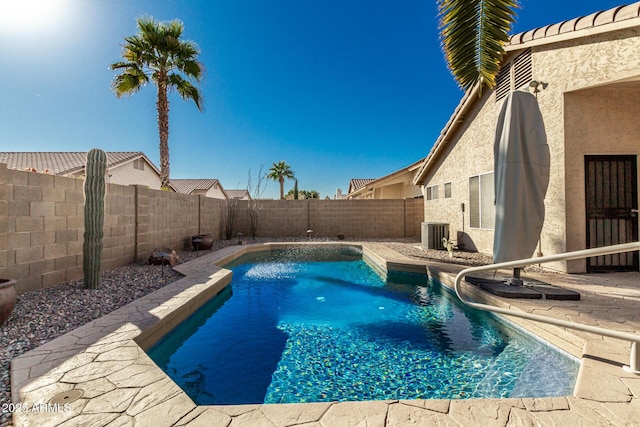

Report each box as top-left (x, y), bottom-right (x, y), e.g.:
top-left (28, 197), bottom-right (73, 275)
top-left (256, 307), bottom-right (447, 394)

top-left (149, 248), bottom-right (578, 404)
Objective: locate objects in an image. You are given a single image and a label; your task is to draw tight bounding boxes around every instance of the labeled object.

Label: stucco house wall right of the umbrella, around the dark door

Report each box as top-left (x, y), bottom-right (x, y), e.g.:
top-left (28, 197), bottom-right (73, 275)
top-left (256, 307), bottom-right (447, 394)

top-left (532, 28), bottom-right (640, 272)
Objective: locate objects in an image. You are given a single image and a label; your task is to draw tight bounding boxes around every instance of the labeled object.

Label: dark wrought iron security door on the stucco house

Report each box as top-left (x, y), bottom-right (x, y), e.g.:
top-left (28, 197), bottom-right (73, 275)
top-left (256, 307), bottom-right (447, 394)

top-left (585, 156), bottom-right (638, 272)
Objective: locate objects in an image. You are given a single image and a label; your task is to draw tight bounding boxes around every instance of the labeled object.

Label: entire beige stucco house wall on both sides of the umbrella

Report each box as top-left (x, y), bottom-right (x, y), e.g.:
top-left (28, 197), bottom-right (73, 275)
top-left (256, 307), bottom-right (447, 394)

top-left (423, 22), bottom-right (640, 272)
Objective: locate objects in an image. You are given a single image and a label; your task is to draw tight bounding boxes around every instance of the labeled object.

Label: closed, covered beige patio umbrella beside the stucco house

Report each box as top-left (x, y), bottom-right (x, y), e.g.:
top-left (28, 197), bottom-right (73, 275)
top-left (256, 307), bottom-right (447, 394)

top-left (493, 91), bottom-right (550, 268)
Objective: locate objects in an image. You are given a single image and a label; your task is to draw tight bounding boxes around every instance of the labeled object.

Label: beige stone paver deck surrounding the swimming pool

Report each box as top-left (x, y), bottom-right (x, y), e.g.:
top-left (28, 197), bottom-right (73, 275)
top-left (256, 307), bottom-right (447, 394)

top-left (6, 243), bottom-right (640, 427)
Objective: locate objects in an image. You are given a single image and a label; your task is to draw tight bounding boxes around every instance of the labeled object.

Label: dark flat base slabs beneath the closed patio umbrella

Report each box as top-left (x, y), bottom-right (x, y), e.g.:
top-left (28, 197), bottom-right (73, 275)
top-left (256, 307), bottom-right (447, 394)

top-left (465, 276), bottom-right (580, 301)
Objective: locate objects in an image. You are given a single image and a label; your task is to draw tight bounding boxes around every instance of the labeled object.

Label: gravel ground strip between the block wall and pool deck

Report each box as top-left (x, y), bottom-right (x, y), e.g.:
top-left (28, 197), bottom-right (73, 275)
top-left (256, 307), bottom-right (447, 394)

top-left (0, 238), bottom-right (491, 427)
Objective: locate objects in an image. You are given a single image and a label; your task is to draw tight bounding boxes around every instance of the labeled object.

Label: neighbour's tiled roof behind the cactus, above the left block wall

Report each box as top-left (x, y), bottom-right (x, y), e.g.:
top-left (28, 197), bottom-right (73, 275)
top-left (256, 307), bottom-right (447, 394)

top-left (0, 151), bottom-right (160, 175)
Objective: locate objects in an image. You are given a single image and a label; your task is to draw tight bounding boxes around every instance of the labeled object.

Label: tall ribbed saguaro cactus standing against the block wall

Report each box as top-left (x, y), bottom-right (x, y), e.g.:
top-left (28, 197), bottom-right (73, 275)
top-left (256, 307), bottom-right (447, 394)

top-left (82, 148), bottom-right (107, 289)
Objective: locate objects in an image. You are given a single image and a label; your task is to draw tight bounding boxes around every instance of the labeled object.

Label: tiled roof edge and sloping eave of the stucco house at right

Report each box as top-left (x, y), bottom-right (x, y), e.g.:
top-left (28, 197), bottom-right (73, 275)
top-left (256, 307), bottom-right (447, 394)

top-left (413, 2), bottom-right (640, 185)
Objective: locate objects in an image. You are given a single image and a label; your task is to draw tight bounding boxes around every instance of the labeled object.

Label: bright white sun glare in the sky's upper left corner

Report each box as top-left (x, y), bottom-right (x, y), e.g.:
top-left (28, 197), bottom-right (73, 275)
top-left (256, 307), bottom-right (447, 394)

top-left (0, 0), bottom-right (67, 33)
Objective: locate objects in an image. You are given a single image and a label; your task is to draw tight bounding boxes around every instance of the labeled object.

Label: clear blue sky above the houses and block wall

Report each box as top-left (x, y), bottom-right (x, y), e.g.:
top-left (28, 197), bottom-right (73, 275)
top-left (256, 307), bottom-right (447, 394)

top-left (0, 0), bottom-right (624, 198)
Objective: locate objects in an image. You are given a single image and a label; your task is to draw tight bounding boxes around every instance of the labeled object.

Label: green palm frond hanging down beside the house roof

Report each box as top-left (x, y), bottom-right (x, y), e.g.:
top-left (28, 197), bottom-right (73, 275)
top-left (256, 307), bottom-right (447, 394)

top-left (438, 0), bottom-right (518, 89)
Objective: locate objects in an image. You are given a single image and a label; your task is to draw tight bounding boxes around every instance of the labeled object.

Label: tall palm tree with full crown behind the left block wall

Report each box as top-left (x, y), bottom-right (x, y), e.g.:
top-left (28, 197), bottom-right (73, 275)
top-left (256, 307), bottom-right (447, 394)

top-left (110, 18), bottom-right (203, 189)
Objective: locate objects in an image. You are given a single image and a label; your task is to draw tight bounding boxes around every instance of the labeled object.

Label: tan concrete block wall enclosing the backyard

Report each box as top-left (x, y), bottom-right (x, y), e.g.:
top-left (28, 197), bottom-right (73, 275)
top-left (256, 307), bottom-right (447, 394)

top-left (0, 164), bottom-right (424, 293)
